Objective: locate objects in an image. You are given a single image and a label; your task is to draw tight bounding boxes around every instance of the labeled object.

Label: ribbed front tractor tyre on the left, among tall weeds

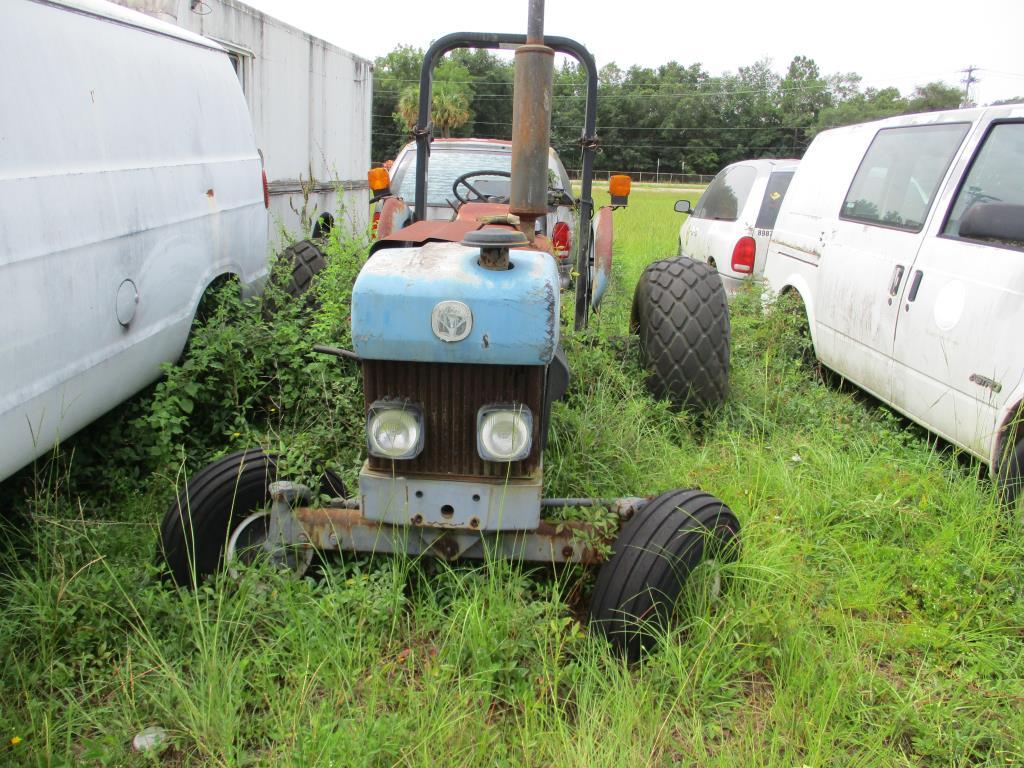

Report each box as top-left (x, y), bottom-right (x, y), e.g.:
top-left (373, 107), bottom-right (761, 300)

top-left (157, 449), bottom-right (346, 587)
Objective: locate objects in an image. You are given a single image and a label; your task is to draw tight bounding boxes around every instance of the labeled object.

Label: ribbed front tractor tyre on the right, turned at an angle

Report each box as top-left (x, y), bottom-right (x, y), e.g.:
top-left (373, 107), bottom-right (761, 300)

top-left (590, 489), bottom-right (739, 660)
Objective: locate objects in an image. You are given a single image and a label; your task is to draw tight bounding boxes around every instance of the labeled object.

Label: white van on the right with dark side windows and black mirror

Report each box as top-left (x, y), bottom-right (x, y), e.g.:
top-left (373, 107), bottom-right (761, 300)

top-left (765, 104), bottom-right (1024, 505)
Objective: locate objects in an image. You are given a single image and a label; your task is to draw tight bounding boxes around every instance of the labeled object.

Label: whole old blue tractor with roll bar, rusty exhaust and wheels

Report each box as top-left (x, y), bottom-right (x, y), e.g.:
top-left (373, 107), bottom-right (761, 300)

top-left (160, 0), bottom-right (739, 657)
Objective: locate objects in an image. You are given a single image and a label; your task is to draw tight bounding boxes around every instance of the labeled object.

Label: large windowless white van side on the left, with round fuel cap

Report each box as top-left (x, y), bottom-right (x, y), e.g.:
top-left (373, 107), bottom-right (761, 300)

top-left (0, 0), bottom-right (267, 479)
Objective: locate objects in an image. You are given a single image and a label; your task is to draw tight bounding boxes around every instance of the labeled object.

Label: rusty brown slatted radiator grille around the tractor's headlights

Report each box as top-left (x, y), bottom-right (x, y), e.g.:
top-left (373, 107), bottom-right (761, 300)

top-left (362, 360), bottom-right (544, 477)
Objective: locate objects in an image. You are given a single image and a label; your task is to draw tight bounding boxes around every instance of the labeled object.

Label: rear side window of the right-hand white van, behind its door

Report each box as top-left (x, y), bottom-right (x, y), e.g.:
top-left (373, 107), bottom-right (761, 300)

top-left (840, 123), bottom-right (971, 232)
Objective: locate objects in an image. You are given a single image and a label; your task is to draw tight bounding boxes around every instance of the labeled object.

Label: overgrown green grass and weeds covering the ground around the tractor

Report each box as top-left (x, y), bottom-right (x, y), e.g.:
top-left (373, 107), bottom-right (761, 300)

top-left (0, 190), bottom-right (1024, 767)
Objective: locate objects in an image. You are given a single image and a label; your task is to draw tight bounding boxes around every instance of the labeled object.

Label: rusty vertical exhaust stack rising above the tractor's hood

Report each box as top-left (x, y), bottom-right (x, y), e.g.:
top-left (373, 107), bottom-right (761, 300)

top-left (511, 0), bottom-right (555, 243)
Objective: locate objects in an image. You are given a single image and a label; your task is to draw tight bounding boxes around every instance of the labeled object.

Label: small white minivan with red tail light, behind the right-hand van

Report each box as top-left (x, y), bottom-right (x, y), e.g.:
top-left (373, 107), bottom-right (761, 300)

top-left (676, 160), bottom-right (800, 296)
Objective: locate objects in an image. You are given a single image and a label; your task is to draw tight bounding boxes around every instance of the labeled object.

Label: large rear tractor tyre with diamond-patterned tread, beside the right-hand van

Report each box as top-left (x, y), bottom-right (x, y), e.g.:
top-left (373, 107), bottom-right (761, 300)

top-left (633, 256), bottom-right (729, 410)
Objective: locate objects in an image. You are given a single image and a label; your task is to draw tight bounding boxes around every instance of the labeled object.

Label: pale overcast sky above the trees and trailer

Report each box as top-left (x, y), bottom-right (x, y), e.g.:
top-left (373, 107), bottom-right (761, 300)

top-left (246, 0), bottom-right (1024, 104)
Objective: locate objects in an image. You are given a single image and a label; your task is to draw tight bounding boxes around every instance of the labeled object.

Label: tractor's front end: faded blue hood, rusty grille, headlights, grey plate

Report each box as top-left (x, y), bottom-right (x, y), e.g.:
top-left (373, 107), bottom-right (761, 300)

top-left (352, 234), bottom-right (564, 530)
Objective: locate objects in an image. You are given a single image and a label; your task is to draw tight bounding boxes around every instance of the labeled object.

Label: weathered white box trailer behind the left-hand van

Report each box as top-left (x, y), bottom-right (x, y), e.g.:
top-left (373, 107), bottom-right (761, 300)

top-left (115, 0), bottom-right (373, 247)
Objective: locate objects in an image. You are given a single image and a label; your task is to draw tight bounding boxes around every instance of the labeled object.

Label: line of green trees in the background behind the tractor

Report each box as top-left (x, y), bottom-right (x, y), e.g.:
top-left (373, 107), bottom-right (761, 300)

top-left (372, 46), bottom-right (1019, 174)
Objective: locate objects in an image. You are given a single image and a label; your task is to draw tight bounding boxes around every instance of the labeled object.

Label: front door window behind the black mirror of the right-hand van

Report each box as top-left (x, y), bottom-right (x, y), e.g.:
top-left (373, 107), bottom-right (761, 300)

top-left (942, 123), bottom-right (1024, 249)
